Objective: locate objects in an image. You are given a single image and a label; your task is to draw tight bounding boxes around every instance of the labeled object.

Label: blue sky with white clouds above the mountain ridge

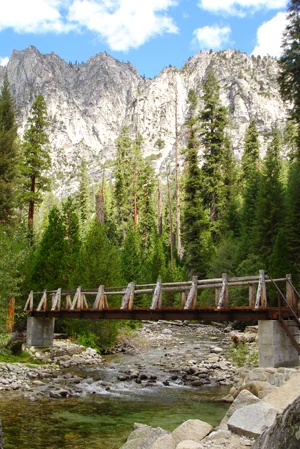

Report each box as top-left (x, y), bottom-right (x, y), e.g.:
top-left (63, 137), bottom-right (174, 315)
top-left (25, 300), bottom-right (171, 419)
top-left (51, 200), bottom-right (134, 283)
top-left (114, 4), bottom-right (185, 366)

top-left (0, 0), bottom-right (288, 78)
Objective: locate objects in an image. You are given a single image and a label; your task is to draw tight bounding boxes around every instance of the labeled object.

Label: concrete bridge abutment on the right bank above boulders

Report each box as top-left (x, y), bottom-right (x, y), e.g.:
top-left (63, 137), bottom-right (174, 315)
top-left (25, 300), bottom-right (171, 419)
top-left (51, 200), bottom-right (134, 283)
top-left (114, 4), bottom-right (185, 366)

top-left (258, 320), bottom-right (299, 368)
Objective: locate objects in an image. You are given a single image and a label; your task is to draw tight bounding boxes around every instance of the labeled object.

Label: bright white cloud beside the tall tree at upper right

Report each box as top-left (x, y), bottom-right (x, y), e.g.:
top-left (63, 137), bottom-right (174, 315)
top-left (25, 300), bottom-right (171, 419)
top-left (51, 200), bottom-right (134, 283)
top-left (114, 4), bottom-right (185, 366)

top-left (252, 12), bottom-right (287, 57)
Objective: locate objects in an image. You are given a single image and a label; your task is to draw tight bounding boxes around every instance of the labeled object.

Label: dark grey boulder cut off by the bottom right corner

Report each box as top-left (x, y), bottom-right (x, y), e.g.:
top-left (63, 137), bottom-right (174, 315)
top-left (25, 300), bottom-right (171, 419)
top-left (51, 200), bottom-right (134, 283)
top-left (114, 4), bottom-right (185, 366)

top-left (252, 396), bottom-right (300, 449)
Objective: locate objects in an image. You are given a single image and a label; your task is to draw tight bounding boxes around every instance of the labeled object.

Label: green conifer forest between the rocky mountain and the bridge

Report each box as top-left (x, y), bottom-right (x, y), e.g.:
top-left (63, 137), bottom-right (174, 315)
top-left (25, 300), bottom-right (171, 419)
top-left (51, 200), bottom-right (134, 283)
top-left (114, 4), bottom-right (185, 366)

top-left (0, 2), bottom-right (300, 345)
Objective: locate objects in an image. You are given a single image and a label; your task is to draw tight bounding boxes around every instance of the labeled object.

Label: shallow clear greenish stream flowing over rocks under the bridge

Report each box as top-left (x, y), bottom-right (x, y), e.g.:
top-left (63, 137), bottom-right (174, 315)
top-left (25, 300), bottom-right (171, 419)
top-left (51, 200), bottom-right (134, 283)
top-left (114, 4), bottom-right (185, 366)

top-left (0, 324), bottom-right (228, 449)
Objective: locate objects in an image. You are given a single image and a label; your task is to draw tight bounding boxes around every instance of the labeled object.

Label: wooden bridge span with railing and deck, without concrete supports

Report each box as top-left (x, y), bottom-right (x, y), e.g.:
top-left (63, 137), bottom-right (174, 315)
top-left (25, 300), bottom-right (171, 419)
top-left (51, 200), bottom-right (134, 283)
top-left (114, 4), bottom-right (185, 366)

top-left (24, 270), bottom-right (299, 321)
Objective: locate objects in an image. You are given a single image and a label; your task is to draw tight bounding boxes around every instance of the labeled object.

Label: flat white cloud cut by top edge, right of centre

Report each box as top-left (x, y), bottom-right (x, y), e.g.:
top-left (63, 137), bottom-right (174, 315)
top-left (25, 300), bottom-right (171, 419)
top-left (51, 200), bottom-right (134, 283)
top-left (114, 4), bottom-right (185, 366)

top-left (198, 0), bottom-right (288, 16)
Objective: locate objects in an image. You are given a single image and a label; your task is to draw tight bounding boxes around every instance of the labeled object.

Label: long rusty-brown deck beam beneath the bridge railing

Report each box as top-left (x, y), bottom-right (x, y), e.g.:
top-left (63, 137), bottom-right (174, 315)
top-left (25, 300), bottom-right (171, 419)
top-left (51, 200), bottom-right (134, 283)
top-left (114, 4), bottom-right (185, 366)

top-left (29, 307), bottom-right (291, 321)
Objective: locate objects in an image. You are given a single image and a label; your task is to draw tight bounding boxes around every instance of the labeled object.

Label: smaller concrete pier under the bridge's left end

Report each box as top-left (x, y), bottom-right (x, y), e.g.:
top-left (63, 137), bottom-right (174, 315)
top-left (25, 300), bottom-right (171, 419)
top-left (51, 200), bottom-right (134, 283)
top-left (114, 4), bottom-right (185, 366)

top-left (26, 316), bottom-right (55, 348)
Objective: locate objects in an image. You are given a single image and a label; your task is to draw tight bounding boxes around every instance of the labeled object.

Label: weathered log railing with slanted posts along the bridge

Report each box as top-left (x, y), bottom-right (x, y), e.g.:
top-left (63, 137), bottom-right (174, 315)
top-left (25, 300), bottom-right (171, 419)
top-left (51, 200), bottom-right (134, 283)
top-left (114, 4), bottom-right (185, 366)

top-left (24, 270), bottom-right (298, 312)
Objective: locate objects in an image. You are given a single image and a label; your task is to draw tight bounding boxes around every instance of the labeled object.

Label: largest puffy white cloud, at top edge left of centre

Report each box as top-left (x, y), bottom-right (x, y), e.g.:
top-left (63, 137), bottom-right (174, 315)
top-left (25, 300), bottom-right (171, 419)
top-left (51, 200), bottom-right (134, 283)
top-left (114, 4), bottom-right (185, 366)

top-left (68, 0), bottom-right (178, 51)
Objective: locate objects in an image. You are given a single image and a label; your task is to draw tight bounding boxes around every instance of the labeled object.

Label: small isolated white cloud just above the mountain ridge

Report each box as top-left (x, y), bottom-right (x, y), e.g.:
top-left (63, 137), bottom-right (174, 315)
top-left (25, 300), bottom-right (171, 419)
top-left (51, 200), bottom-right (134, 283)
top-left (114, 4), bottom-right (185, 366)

top-left (193, 25), bottom-right (231, 50)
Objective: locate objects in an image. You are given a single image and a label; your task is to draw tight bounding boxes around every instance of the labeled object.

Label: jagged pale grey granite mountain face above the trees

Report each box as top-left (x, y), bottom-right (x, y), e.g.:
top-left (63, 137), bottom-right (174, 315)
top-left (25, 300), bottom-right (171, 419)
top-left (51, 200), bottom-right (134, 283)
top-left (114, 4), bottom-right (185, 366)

top-left (0, 46), bottom-right (286, 195)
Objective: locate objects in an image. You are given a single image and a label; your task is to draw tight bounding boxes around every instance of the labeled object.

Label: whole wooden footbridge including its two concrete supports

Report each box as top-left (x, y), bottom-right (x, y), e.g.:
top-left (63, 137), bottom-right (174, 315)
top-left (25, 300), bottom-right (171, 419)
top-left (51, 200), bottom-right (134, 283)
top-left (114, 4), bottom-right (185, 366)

top-left (24, 270), bottom-right (300, 366)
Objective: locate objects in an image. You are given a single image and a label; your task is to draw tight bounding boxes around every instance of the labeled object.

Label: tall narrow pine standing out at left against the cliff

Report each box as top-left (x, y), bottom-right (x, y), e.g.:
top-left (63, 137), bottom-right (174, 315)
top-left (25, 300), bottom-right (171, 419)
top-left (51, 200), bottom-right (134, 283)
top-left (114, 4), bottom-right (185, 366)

top-left (21, 95), bottom-right (51, 240)
